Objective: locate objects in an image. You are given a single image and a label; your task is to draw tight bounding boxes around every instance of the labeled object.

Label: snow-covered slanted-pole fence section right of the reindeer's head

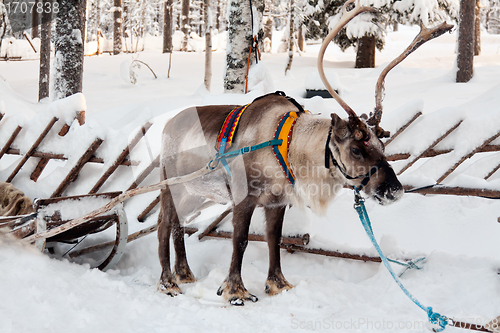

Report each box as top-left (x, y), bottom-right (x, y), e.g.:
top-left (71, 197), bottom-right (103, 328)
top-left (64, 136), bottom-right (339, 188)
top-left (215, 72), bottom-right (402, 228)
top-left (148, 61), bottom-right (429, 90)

top-left (383, 103), bottom-right (500, 198)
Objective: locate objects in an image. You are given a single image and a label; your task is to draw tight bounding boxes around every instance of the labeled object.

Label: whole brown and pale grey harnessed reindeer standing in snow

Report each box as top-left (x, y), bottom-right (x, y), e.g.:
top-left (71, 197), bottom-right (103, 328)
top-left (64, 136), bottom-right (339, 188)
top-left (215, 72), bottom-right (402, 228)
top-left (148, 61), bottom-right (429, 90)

top-left (158, 0), bottom-right (454, 305)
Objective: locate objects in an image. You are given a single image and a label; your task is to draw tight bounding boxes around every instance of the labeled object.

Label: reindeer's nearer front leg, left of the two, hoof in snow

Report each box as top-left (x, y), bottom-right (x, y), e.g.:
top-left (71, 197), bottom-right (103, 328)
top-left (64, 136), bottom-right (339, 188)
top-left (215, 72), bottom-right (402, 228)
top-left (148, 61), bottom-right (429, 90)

top-left (217, 196), bottom-right (258, 305)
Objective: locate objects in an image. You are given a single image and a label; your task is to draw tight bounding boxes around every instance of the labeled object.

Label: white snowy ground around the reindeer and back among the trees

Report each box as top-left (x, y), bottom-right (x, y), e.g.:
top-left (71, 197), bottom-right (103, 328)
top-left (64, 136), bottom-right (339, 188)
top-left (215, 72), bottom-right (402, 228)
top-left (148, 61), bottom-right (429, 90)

top-left (0, 27), bottom-right (500, 333)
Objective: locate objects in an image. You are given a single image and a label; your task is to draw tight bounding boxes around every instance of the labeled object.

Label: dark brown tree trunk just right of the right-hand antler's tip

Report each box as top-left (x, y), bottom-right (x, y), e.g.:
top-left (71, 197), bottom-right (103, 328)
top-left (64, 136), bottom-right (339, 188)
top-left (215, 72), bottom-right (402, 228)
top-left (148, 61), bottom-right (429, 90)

top-left (457, 0), bottom-right (476, 82)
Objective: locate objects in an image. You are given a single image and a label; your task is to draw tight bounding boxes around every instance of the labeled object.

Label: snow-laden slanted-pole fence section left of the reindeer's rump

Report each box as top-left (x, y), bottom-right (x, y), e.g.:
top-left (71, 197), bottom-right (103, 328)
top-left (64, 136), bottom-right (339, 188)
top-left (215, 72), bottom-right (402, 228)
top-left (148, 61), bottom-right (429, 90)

top-left (0, 94), bottom-right (161, 208)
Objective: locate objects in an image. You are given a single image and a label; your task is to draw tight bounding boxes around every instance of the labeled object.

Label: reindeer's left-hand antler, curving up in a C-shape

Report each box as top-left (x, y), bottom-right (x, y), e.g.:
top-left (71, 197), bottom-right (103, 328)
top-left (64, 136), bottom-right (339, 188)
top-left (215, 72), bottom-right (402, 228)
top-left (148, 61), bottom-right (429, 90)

top-left (318, 0), bottom-right (376, 117)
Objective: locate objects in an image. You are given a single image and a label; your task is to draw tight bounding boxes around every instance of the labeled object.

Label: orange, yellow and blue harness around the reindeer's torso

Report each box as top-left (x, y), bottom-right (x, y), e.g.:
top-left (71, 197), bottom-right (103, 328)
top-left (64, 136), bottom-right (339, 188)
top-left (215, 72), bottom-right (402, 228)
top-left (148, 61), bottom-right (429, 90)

top-left (211, 92), bottom-right (307, 186)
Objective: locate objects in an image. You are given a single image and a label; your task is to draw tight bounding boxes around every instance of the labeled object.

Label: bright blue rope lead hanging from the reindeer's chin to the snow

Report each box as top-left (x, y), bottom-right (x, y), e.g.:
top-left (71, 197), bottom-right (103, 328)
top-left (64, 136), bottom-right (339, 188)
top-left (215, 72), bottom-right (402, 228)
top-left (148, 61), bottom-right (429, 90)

top-left (354, 187), bottom-right (448, 332)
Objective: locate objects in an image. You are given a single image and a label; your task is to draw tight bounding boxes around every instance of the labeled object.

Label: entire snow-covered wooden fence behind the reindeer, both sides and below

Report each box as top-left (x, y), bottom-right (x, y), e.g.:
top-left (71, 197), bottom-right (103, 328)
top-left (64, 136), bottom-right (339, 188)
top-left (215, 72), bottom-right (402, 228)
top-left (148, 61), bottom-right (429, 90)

top-left (0, 95), bottom-right (500, 262)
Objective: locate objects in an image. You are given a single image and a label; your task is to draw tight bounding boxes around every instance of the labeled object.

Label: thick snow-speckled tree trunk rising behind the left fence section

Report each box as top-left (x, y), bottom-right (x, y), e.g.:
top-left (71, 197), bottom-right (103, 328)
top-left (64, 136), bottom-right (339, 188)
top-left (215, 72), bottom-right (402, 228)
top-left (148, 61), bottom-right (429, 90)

top-left (53, 0), bottom-right (87, 100)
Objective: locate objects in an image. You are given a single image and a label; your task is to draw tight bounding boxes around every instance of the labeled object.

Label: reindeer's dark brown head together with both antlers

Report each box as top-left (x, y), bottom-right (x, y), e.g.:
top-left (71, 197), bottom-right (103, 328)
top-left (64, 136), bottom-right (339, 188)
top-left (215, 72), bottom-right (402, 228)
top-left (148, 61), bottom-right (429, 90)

top-left (318, 0), bottom-right (453, 204)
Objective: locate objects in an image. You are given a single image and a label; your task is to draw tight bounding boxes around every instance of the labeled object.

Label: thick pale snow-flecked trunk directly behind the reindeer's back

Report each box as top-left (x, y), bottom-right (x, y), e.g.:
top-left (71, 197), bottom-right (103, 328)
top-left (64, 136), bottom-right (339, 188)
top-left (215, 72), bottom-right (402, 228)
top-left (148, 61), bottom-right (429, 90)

top-left (224, 0), bottom-right (264, 93)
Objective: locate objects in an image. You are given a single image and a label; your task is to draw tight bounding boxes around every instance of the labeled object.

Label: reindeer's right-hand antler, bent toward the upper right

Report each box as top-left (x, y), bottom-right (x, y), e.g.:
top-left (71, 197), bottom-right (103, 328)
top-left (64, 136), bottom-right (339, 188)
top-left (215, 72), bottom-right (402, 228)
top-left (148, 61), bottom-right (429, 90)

top-left (368, 22), bottom-right (453, 127)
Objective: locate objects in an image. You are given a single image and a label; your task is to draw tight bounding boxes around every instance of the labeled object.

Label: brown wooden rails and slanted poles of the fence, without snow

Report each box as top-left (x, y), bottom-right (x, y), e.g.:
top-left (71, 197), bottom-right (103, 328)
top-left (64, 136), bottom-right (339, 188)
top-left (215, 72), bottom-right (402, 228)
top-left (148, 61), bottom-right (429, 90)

top-left (0, 103), bottom-right (500, 261)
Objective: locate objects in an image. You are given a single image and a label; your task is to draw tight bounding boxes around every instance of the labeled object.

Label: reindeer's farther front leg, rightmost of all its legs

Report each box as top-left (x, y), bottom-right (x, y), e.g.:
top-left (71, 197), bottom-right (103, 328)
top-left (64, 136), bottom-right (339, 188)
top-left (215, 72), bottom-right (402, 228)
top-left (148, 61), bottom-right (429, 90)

top-left (264, 206), bottom-right (293, 295)
